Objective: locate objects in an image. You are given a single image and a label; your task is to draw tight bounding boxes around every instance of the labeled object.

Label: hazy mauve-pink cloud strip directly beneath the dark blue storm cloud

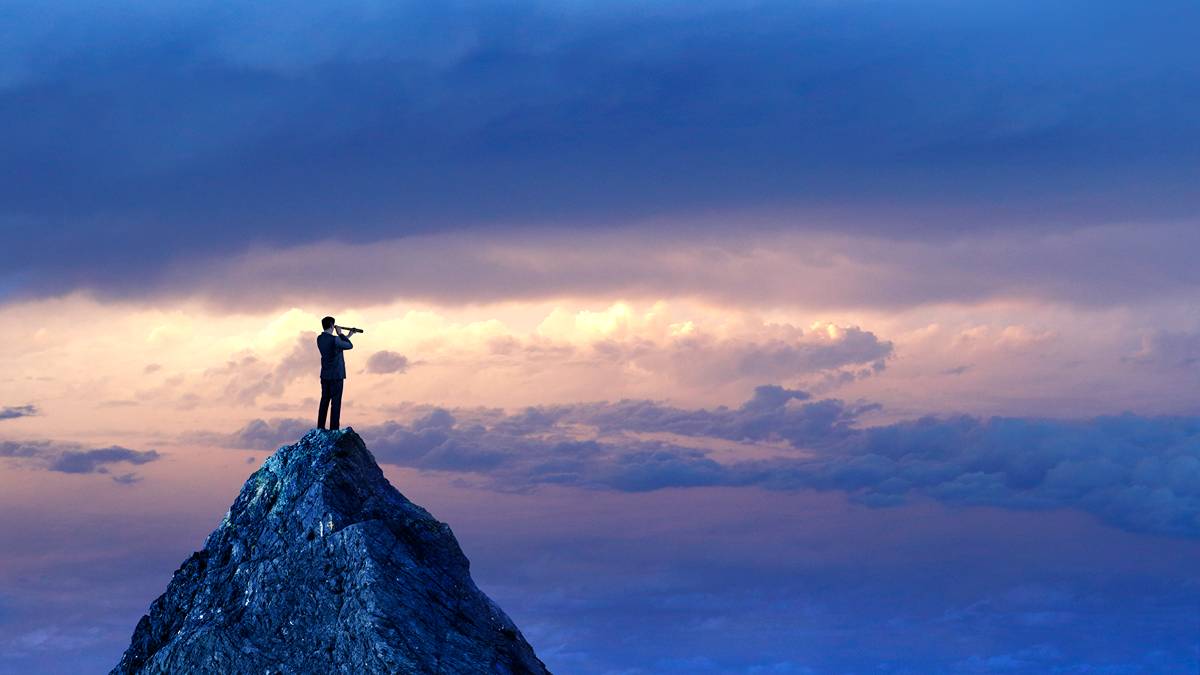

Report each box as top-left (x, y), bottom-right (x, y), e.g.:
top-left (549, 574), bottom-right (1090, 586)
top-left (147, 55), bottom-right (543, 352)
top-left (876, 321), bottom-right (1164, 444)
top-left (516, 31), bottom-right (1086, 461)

top-left (114, 223), bottom-right (1200, 312)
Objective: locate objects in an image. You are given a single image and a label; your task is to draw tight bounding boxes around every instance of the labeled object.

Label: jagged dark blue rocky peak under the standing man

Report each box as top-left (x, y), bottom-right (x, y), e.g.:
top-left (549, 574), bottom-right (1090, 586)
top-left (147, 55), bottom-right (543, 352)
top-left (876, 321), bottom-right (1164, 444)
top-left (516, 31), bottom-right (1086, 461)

top-left (113, 429), bottom-right (547, 675)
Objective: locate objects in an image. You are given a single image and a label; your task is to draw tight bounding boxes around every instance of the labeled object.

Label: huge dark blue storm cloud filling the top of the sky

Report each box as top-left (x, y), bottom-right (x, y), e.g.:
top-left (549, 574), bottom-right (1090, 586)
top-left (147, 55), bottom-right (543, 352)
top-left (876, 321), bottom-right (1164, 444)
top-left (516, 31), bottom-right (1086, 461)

top-left (0, 0), bottom-right (1200, 298)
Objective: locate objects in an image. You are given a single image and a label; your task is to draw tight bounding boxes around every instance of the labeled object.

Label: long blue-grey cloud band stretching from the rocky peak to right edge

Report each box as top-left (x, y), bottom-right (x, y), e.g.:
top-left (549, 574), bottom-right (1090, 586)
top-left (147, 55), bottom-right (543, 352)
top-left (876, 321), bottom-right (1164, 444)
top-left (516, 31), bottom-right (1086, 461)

top-left (226, 386), bottom-right (1200, 537)
